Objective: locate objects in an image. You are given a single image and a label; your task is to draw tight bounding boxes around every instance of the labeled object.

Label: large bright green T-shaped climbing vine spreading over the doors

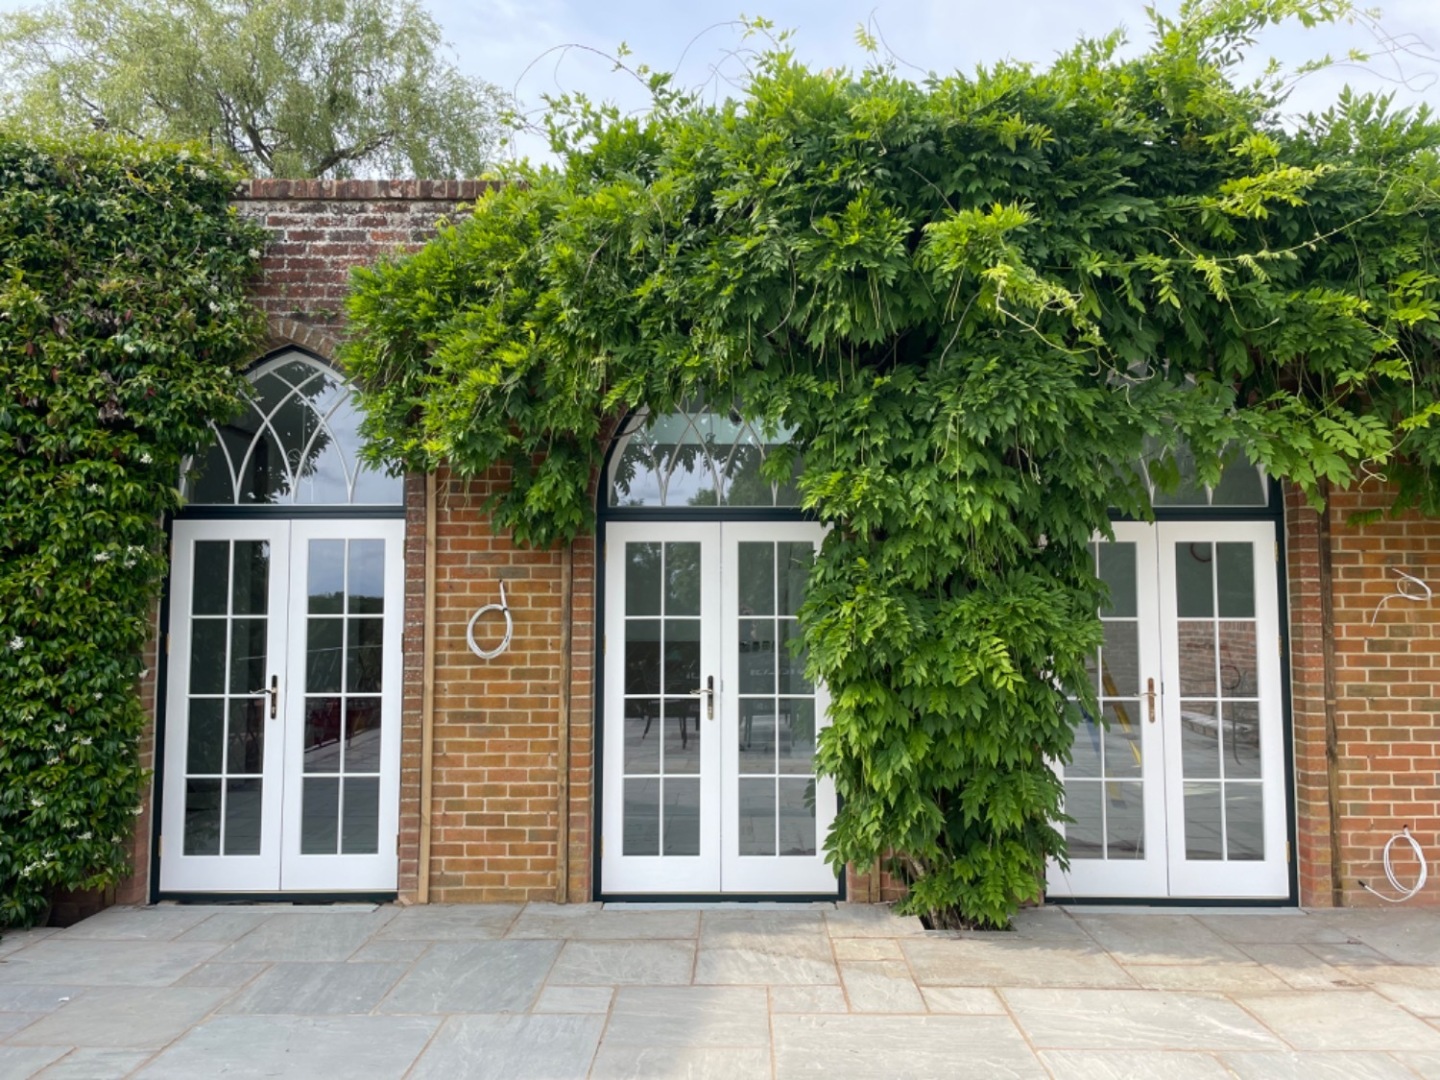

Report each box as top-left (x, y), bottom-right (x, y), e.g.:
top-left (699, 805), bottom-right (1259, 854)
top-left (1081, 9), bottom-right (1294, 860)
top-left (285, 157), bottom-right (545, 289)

top-left (347, 0), bottom-right (1440, 926)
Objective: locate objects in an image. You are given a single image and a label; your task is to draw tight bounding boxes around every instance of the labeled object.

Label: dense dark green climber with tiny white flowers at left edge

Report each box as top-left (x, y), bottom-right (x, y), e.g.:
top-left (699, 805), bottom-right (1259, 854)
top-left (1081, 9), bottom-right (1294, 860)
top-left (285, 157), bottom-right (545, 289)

top-left (0, 132), bottom-right (264, 926)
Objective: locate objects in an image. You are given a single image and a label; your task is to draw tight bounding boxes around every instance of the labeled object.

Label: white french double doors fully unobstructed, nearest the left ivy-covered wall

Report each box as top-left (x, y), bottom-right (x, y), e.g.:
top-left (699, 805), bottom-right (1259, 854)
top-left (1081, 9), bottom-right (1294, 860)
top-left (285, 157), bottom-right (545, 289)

top-left (160, 518), bottom-right (405, 893)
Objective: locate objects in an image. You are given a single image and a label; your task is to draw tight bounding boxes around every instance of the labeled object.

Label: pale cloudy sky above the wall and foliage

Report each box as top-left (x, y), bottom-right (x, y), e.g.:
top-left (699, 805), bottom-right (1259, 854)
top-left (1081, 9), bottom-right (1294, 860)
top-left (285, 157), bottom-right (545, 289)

top-left (0, 0), bottom-right (1440, 160)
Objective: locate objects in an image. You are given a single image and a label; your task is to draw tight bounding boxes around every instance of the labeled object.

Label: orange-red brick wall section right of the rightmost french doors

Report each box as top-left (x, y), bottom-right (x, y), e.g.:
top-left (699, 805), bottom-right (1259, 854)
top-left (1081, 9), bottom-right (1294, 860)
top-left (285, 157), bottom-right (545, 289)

top-left (1287, 487), bottom-right (1440, 906)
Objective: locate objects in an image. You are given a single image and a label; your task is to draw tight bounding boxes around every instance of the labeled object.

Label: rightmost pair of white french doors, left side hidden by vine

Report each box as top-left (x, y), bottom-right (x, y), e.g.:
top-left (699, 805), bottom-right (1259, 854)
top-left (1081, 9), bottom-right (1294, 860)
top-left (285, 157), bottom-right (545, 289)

top-left (1048, 521), bottom-right (1290, 899)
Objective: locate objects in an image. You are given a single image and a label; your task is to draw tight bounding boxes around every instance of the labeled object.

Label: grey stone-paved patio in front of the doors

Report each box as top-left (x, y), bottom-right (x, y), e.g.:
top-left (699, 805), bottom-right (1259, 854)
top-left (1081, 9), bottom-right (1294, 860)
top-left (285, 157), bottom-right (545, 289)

top-left (0, 904), bottom-right (1440, 1080)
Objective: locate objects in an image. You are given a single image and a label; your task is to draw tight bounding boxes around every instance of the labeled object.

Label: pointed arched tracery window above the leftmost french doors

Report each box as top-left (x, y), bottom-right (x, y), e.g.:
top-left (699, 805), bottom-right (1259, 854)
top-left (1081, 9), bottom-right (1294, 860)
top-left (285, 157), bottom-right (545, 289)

top-left (181, 350), bottom-right (403, 507)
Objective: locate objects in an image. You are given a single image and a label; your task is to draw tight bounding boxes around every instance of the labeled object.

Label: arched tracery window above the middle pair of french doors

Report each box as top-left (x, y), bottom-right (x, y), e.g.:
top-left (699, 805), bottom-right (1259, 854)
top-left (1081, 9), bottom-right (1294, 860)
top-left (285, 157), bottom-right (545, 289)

top-left (608, 402), bottom-right (801, 508)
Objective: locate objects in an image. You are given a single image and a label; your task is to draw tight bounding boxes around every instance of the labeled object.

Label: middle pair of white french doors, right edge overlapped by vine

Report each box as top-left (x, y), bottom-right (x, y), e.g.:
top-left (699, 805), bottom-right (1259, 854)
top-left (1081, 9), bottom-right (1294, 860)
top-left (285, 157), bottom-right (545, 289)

top-left (600, 523), bottom-right (838, 896)
